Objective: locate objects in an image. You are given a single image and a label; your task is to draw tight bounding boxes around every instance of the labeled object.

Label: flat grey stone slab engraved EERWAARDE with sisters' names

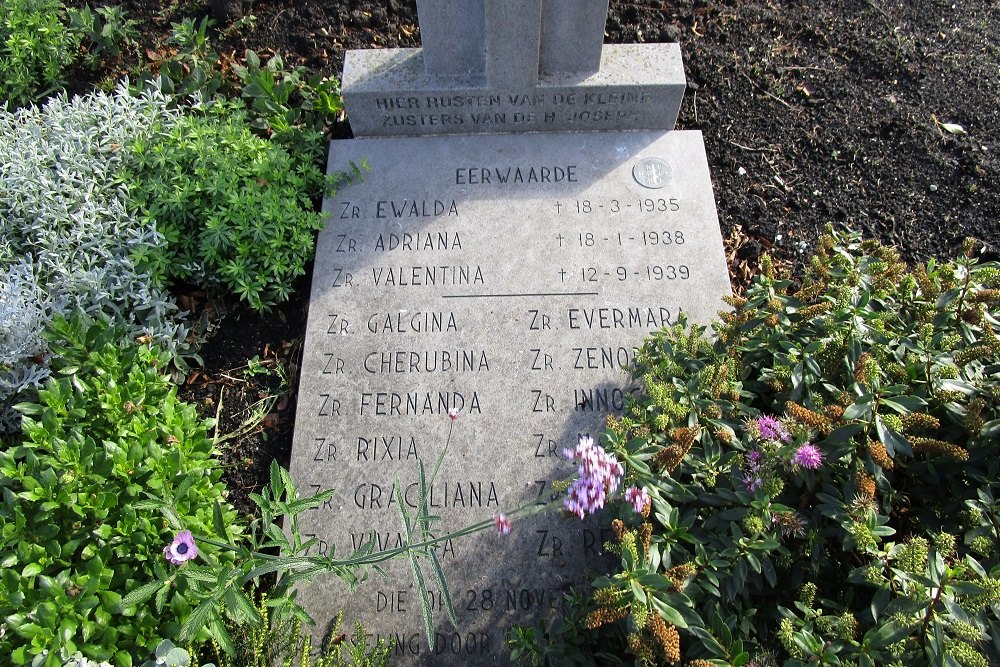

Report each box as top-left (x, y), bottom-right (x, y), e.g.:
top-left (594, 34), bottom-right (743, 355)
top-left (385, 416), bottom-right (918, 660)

top-left (291, 129), bottom-right (729, 665)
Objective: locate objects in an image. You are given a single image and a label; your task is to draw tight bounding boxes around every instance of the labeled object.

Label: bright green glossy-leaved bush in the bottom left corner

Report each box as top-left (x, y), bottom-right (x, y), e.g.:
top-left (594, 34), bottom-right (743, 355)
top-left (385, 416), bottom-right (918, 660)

top-left (0, 315), bottom-right (240, 667)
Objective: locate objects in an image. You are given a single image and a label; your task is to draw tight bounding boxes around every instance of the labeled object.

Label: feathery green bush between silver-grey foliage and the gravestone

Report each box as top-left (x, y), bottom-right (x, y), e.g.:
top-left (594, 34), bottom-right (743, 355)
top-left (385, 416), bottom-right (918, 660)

top-left (125, 103), bottom-right (336, 310)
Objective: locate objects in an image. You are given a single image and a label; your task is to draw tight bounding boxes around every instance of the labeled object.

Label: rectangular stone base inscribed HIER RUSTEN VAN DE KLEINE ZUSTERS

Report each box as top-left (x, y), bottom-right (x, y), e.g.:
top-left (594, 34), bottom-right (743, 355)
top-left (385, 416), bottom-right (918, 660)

top-left (342, 44), bottom-right (686, 137)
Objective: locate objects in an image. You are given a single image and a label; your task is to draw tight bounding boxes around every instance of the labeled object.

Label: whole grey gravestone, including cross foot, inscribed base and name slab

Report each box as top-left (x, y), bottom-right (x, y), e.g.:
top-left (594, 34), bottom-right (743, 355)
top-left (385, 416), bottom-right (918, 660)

top-left (291, 0), bottom-right (729, 665)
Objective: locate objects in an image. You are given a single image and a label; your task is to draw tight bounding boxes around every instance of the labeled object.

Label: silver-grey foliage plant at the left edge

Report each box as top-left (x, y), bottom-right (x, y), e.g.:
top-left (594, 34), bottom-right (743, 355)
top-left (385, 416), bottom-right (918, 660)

top-left (0, 81), bottom-right (187, 432)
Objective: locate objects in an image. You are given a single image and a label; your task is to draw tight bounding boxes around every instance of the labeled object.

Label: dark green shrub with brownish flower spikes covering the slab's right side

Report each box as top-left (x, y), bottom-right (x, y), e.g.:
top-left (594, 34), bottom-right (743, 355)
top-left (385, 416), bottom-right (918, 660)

top-left (588, 231), bottom-right (1000, 666)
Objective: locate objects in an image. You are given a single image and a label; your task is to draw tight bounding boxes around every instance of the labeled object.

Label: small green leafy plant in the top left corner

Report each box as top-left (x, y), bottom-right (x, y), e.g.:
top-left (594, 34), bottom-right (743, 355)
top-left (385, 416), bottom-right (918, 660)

top-left (0, 0), bottom-right (80, 106)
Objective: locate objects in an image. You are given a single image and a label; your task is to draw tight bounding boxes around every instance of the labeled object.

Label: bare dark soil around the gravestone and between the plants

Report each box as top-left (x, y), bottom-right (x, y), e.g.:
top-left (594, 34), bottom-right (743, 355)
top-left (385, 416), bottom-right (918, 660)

top-left (66, 0), bottom-right (1000, 508)
